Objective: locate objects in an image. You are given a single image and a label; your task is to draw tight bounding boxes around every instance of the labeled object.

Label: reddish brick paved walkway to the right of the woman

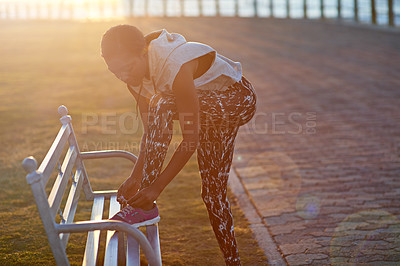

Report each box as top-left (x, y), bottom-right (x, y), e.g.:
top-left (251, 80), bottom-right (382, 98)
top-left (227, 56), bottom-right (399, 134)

top-left (139, 18), bottom-right (400, 265)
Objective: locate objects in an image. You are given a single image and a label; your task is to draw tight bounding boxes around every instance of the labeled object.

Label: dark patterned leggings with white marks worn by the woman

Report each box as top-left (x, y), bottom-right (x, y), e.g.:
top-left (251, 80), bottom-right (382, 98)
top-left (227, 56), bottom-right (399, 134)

top-left (141, 77), bottom-right (256, 265)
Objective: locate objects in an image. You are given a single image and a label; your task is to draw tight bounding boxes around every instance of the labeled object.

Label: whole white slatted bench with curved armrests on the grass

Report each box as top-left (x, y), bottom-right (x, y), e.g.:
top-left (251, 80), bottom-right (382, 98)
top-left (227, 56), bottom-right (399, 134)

top-left (23, 105), bottom-right (162, 265)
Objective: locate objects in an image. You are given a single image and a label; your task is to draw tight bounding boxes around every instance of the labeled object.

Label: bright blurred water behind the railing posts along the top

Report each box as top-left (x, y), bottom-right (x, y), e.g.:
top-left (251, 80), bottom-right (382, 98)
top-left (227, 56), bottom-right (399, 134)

top-left (0, 0), bottom-right (400, 25)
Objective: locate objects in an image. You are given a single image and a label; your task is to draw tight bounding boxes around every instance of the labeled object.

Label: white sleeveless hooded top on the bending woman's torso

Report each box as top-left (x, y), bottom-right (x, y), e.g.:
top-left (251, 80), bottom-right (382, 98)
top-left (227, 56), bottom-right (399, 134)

top-left (131, 29), bottom-right (242, 99)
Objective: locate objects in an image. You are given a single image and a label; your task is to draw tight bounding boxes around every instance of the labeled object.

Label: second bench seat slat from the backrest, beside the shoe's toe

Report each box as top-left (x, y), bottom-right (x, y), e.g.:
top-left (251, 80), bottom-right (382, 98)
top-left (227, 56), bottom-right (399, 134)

top-left (104, 195), bottom-right (120, 266)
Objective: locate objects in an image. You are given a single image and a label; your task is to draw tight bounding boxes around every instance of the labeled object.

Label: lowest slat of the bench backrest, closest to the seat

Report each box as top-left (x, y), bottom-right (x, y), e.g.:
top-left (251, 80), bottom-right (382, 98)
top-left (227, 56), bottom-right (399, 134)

top-left (60, 170), bottom-right (83, 247)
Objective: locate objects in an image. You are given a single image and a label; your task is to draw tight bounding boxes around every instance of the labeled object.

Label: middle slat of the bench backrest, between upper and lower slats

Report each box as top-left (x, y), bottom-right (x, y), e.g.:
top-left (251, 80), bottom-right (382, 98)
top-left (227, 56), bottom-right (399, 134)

top-left (49, 146), bottom-right (78, 217)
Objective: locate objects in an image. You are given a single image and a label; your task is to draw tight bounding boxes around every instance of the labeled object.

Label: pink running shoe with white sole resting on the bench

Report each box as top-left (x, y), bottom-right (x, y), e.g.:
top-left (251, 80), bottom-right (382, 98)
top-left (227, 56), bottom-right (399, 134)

top-left (110, 203), bottom-right (160, 227)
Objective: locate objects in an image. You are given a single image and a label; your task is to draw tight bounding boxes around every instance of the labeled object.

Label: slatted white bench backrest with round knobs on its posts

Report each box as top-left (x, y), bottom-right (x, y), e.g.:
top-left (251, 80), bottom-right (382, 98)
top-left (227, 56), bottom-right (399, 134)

top-left (23, 105), bottom-right (94, 265)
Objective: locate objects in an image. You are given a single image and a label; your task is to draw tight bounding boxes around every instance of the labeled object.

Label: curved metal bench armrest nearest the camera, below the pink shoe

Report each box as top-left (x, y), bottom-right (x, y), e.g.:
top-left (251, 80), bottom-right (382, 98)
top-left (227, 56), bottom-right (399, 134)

top-left (56, 220), bottom-right (161, 266)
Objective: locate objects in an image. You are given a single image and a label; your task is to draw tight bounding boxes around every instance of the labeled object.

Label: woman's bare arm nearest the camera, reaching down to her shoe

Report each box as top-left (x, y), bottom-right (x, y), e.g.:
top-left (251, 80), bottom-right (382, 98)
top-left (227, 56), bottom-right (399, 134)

top-left (129, 60), bottom-right (199, 207)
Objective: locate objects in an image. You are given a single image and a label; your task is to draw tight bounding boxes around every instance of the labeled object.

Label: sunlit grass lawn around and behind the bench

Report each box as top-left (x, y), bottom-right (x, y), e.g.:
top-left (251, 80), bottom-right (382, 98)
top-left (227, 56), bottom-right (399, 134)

top-left (0, 19), bottom-right (266, 265)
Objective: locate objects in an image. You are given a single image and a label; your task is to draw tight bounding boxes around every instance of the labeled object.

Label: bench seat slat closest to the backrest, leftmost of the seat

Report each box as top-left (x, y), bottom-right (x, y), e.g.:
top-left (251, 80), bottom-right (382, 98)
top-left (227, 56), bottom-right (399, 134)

top-left (82, 197), bottom-right (104, 266)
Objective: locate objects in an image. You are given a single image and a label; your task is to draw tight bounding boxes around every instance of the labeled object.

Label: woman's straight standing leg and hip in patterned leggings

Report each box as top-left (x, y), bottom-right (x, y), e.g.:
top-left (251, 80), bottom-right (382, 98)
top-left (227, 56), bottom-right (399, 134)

top-left (197, 78), bottom-right (256, 265)
